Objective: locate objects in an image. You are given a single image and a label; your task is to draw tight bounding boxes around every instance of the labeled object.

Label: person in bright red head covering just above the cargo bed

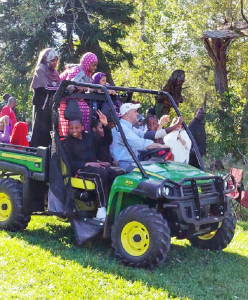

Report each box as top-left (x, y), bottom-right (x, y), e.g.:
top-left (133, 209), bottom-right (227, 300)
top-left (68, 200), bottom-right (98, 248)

top-left (10, 122), bottom-right (29, 147)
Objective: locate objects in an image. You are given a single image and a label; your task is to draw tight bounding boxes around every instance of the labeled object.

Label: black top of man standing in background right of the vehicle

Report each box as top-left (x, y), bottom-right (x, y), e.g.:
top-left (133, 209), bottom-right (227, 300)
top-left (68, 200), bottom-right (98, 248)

top-left (189, 118), bottom-right (207, 155)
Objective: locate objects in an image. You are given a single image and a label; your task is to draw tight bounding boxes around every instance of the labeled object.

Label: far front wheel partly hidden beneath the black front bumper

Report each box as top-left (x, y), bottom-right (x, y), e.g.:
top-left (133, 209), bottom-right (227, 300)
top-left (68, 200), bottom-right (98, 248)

top-left (189, 214), bottom-right (236, 251)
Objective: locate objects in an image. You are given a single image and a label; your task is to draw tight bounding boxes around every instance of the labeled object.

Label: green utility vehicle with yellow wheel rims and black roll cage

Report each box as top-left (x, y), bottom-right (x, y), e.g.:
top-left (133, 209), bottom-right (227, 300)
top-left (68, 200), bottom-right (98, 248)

top-left (0, 81), bottom-right (235, 269)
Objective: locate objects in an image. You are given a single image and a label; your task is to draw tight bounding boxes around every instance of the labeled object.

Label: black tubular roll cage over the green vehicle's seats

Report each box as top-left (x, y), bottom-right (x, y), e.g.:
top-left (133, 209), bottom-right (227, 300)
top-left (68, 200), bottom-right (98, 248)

top-left (52, 80), bottom-right (205, 178)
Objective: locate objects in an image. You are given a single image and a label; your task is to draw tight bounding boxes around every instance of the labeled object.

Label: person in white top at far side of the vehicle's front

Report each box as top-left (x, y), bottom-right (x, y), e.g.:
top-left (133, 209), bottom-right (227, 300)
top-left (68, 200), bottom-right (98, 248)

top-left (164, 117), bottom-right (191, 164)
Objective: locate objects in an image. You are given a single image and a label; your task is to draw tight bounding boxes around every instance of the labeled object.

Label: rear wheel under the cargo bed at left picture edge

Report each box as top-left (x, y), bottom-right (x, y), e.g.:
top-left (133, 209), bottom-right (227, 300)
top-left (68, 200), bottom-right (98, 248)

top-left (0, 178), bottom-right (31, 232)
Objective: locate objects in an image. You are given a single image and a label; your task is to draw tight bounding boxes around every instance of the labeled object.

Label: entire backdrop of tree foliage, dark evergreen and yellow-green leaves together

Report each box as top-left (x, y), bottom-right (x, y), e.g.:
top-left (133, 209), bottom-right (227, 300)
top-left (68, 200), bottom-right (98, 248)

top-left (0, 0), bottom-right (248, 156)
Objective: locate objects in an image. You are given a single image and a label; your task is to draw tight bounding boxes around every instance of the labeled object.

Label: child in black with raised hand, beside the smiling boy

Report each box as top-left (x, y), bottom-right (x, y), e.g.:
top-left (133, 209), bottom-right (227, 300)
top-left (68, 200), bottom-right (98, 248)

top-left (91, 115), bottom-right (114, 165)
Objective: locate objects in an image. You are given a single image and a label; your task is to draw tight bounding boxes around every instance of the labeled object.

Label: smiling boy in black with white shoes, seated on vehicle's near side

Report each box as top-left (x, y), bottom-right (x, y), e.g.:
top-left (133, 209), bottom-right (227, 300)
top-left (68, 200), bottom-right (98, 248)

top-left (62, 100), bottom-right (117, 221)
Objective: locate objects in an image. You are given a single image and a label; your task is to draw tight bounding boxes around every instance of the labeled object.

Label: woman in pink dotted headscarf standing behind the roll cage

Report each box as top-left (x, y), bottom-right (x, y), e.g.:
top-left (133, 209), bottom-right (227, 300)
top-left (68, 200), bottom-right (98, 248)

top-left (60, 52), bottom-right (98, 136)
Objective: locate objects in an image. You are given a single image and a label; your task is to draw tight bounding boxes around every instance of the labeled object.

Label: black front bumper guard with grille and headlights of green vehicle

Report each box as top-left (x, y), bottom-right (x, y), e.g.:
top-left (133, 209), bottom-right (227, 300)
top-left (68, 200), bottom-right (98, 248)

top-left (161, 174), bottom-right (236, 227)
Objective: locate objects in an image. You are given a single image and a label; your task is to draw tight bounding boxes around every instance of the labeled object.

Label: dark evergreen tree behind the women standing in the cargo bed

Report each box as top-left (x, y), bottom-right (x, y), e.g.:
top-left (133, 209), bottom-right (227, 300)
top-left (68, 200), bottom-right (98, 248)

top-left (0, 0), bottom-right (134, 107)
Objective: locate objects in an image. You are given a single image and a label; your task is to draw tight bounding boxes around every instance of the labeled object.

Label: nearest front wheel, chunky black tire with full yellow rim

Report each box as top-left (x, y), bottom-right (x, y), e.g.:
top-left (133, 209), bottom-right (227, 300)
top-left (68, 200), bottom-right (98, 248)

top-left (111, 204), bottom-right (170, 269)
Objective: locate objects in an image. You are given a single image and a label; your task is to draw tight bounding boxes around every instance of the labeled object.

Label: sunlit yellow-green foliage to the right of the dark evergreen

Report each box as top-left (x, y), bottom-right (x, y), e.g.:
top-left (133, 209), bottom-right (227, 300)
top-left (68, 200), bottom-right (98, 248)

top-left (114, 0), bottom-right (248, 156)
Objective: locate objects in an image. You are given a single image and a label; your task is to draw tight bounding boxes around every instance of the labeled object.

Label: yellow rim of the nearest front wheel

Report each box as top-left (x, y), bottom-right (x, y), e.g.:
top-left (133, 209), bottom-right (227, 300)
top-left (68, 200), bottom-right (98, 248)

top-left (121, 221), bottom-right (150, 256)
